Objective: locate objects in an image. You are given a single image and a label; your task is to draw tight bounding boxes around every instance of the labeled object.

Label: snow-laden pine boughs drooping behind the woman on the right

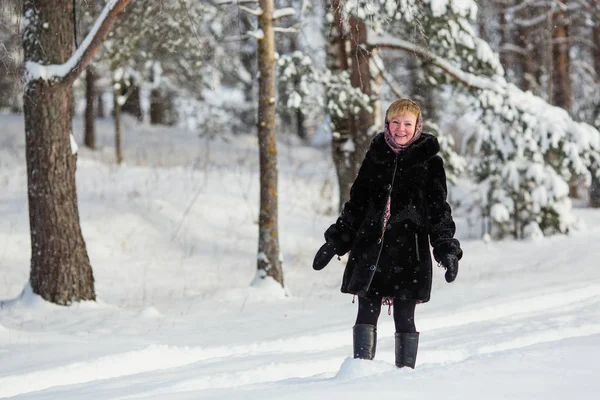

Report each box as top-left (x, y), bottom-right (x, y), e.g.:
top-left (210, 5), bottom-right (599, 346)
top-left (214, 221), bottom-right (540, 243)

top-left (345, 0), bottom-right (600, 238)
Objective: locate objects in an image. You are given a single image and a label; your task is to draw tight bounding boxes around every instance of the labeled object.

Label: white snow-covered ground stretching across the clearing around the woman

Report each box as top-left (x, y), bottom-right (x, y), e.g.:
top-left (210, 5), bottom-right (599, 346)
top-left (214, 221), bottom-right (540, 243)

top-left (0, 115), bottom-right (600, 400)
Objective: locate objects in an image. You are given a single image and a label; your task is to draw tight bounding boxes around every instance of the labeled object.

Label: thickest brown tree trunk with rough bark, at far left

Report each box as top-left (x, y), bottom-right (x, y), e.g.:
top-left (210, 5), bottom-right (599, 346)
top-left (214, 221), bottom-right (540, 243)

top-left (23, 0), bottom-right (96, 305)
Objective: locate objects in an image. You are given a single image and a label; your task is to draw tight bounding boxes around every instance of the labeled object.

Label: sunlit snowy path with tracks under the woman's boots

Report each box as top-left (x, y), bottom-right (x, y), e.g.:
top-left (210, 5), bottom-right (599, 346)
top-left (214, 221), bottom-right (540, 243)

top-left (0, 270), bottom-right (600, 399)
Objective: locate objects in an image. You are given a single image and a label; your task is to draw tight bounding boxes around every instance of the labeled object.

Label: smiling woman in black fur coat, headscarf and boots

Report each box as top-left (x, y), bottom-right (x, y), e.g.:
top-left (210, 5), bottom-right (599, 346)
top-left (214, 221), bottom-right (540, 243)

top-left (313, 99), bottom-right (463, 368)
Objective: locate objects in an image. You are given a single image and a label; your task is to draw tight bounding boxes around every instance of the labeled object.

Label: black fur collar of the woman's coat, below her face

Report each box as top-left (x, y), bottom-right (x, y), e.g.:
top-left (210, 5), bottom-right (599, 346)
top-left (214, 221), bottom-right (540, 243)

top-left (370, 132), bottom-right (440, 167)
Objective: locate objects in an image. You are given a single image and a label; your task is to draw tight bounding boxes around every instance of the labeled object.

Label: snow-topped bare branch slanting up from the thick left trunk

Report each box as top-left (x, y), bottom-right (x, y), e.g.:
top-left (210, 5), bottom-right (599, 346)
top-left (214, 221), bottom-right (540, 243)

top-left (24, 0), bottom-right (131, 85)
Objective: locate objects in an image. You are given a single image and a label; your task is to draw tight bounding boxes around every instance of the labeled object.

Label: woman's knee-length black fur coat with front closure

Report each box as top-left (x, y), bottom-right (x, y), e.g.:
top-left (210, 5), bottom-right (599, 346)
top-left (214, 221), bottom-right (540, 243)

top-left (325, 133), bottom-right (462, 302)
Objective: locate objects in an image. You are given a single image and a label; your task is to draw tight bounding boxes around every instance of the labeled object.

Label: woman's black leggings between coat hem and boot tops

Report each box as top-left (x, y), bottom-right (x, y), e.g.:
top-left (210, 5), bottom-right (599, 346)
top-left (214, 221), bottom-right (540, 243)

top-left (356, 297), bottom-right (417, 333)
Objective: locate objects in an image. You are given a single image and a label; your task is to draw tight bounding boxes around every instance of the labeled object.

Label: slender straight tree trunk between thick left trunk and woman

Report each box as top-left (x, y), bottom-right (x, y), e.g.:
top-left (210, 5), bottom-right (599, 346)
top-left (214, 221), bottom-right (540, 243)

top-left (257, 0), bottom-right (284, 286)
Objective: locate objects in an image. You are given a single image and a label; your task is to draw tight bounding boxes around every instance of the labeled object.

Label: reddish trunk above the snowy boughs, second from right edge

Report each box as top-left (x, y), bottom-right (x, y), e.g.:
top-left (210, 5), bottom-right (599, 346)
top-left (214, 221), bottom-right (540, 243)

top-left (552, 0), bottom-right (571, 112)
